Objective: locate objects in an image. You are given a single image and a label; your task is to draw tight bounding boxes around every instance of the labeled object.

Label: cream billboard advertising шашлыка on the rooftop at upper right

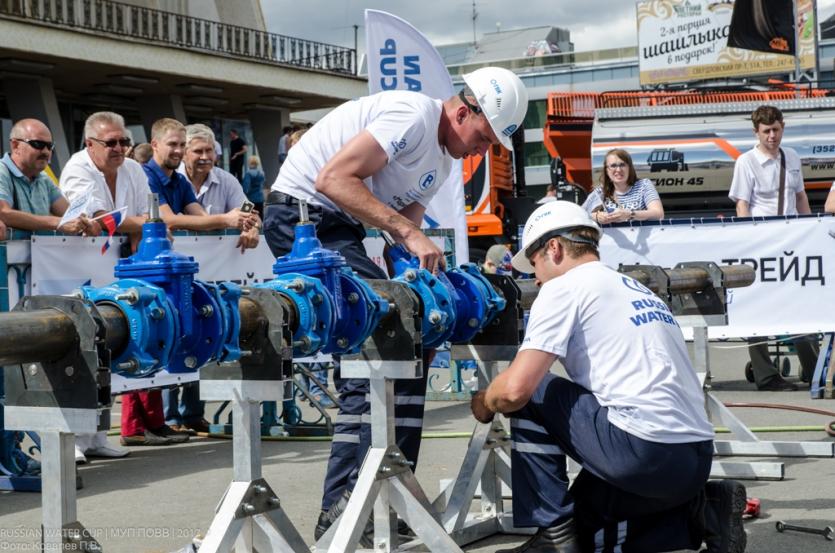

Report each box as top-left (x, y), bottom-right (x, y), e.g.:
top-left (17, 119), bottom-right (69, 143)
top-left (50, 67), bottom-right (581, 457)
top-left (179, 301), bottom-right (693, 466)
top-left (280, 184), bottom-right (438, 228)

top-left (636, 0), bottom-right (817, 85)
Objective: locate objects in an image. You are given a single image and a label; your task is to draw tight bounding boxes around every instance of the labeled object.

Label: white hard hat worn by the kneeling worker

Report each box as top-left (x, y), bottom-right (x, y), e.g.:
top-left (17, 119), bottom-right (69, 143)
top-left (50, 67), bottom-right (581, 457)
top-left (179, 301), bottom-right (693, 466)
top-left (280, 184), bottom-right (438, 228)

top-left (513, 200), bottom-right (601, 273)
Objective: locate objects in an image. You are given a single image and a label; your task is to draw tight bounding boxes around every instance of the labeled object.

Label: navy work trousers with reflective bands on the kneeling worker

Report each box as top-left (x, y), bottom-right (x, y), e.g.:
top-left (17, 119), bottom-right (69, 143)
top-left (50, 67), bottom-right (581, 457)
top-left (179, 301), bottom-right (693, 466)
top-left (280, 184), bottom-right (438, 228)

top-left (509, 374), bottom-right (713, 553)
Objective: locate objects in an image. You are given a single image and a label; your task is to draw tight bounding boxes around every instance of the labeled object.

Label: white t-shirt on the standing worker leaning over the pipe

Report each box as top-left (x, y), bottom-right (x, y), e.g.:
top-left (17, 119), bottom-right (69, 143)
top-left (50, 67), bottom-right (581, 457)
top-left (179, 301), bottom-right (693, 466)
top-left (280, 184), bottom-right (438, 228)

top-left (272, 90), bottom-right (452, 216)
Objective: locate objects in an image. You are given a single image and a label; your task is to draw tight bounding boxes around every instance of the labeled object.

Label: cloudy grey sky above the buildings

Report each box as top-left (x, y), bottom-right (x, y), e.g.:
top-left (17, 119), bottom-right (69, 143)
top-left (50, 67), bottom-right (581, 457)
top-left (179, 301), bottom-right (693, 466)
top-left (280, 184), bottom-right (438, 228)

top-left (261, 0), bottom-right (835, 55)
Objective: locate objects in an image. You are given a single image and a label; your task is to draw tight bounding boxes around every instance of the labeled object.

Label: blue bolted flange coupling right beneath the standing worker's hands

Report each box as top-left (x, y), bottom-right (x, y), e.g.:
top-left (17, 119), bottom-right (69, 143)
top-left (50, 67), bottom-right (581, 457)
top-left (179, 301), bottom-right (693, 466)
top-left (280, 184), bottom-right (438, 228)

top-left (388, 245), bottom-right (458, 348)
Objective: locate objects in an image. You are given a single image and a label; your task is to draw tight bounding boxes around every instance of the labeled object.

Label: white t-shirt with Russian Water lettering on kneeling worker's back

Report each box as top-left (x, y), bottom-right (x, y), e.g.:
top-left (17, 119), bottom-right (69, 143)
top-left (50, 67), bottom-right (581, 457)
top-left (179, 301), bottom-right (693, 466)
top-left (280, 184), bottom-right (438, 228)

top-left (519, 261), bottom-right (713, 443)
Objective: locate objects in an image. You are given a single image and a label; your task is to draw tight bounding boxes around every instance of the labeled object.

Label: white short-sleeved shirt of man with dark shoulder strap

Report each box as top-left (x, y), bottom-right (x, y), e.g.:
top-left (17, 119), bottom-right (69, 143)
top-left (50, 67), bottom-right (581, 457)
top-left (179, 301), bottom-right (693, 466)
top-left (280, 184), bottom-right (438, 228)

top-left (728, 146), bottom-right (804, 217)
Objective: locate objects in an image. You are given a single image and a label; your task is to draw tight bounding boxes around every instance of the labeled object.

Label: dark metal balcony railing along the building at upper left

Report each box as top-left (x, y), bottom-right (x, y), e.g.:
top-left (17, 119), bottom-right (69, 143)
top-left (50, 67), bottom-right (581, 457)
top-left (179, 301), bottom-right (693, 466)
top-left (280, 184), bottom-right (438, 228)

top-left (0, 0), bottom-right (356, 75)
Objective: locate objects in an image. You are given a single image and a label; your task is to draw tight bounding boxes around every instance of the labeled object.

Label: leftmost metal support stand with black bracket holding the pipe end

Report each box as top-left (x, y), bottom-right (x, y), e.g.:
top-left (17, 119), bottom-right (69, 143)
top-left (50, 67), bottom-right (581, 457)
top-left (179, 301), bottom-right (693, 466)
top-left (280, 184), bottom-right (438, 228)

top-left (3, 296), bottom-right (110, 553)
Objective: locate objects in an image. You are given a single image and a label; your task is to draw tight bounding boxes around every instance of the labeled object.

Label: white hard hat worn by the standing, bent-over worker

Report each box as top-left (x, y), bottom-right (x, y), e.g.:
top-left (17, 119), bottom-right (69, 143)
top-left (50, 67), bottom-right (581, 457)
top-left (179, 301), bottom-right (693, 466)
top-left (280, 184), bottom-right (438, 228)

top-left (464, 67), bottom-right (528, 150)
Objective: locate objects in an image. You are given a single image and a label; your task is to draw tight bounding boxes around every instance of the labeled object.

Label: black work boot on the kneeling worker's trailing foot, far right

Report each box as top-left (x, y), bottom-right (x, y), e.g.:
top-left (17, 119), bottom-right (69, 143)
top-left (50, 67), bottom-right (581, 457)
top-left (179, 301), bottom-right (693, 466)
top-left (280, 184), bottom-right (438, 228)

top-left (704, 480), bottom-right (748, 553)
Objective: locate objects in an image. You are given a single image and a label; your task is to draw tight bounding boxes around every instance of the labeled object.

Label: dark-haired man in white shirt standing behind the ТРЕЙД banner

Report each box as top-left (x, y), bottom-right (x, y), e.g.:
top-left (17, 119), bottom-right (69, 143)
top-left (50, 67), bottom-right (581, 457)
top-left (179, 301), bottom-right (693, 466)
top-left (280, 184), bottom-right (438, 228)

top-left (728, 106), bottom-right (818, 392)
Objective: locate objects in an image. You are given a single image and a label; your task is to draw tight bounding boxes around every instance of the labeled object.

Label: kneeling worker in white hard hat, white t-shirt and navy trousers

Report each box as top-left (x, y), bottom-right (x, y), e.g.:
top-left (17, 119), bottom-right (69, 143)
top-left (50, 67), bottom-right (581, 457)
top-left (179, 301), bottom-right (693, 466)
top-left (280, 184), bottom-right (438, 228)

top-left (471, 201), bottom-right (746, 553)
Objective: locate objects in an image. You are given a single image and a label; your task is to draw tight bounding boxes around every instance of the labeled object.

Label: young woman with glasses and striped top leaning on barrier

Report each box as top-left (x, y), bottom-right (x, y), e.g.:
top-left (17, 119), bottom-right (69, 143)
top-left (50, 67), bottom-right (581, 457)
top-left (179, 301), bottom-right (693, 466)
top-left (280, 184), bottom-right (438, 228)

top-left (583, 149), bottom-right (664, 225)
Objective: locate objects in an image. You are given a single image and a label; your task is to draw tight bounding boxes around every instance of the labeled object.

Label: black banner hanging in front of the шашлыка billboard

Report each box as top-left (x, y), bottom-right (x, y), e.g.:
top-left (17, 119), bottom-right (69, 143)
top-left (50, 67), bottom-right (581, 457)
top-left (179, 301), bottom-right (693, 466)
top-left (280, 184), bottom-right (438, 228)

top-left (728, 0), bottom-right (795, 56)
